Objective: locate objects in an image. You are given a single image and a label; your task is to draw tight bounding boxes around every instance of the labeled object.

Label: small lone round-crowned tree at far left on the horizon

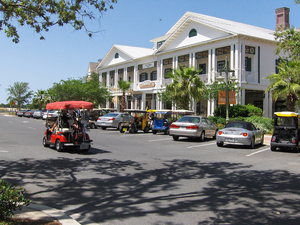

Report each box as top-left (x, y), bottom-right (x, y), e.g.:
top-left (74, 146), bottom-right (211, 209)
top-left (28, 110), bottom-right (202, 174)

top-left (6, 82), bottom-right (33, 110)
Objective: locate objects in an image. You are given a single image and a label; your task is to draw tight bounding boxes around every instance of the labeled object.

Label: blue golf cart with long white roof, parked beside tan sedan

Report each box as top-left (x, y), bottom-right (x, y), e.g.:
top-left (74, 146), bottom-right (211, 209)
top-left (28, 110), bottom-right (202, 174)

top-left (152, 109), bottom-right (194, 134)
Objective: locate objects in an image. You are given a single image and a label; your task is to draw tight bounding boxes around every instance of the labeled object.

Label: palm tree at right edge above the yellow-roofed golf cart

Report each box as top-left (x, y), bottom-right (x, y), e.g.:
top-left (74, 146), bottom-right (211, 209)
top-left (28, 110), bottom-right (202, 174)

top-left (266, 58), bottom-right (300, 111)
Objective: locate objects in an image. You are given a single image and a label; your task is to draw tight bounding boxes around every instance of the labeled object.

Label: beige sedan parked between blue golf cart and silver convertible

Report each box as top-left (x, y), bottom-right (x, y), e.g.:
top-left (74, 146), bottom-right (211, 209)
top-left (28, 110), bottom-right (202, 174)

top-left (169, 116), bottom-right (218, 141)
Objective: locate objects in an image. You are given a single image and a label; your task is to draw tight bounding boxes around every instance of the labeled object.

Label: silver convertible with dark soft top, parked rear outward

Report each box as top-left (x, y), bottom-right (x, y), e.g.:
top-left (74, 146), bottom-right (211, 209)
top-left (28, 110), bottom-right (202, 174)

top-left (216, 121), bottom-right (264, 148)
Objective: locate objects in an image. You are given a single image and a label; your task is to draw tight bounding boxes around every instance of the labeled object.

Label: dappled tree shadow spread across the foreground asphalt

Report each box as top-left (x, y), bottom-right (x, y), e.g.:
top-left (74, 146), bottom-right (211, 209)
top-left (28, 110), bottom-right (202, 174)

top-left (0, 157), bottom-right (300, 225)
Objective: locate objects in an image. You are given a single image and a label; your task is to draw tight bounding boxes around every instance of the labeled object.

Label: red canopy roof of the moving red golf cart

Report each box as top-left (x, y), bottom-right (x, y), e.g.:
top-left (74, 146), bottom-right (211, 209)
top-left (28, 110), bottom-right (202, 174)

top-left (46, 101), bottom-right (93, 110)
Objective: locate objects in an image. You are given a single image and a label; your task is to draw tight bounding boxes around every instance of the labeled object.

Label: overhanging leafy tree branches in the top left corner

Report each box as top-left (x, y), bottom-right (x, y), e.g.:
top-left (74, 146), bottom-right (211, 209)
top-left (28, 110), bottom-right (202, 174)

top-left (0, 0), bottom-right (117, 43)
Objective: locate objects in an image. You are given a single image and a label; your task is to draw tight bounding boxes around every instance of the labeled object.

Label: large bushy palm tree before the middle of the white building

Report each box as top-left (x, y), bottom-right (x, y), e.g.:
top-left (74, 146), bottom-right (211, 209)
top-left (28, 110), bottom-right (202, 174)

top-left (166, 66), bottom-right (205, 109)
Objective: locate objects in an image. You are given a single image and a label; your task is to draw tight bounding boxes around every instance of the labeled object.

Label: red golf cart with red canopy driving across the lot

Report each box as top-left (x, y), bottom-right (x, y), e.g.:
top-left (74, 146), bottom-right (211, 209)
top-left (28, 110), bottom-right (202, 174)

top-left (43, 101), bottom-right (93, 151)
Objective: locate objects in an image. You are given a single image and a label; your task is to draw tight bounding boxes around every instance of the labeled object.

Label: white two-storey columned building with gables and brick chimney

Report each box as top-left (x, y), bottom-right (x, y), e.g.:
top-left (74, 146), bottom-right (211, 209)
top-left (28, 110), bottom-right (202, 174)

top-left (92, 8), bottom-right (289, 117)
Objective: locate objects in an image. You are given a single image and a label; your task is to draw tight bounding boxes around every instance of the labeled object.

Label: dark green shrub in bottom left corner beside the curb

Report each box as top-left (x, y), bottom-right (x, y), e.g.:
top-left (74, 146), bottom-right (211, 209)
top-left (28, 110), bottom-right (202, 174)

top-left (0, 180), bottom-right (30, 219)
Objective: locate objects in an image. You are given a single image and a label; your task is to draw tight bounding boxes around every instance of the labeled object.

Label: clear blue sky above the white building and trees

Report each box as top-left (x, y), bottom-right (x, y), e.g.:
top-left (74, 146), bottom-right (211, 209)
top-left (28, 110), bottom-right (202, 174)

top-left (0, 0), bottom-right (300, 103)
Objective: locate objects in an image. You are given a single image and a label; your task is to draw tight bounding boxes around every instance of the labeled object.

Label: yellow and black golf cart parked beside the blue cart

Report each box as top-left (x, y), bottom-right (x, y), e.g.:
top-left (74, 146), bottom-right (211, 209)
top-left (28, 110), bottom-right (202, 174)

top-left (120, 109), bottom-right (151, 133)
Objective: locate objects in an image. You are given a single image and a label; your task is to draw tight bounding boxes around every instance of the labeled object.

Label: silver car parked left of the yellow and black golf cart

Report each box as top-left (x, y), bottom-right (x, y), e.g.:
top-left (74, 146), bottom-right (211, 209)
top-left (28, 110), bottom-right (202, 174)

top-left (97, 112), bottom-right (133, 130)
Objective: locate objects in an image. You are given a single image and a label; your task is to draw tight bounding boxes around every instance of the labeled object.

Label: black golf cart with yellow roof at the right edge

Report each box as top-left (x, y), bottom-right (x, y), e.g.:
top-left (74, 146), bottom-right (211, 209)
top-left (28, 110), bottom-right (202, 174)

top-left (270, 112), bottom-right (300, 152)
